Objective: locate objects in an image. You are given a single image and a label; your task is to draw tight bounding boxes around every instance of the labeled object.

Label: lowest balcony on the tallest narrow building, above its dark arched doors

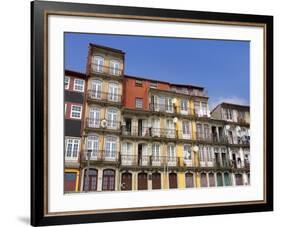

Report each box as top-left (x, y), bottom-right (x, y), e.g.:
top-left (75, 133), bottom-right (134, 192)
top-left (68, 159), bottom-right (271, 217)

top-left (81, 150), bottom-right (118, 164)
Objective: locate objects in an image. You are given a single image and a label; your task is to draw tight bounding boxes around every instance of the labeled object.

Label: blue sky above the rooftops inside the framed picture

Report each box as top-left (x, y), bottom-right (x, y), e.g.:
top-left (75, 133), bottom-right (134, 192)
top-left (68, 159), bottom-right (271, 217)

top-left (65, 33), bottom-right (250, 107)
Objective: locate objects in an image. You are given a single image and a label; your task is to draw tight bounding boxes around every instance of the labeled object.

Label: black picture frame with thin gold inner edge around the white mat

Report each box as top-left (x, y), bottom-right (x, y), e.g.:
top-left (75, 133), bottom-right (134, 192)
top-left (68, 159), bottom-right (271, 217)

top-left (31, 1), bottom-right (273, 226)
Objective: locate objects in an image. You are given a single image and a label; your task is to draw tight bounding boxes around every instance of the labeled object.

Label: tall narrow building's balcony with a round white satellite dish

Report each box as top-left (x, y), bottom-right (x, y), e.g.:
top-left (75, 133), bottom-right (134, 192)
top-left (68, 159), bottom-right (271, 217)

top-left (86, 118), bottom-right (121, 132)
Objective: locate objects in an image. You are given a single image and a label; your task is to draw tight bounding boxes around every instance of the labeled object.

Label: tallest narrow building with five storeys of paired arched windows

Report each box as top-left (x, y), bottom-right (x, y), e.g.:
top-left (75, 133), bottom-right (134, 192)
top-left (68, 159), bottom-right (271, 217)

top-left (80, 44), bottom-right (124, 191)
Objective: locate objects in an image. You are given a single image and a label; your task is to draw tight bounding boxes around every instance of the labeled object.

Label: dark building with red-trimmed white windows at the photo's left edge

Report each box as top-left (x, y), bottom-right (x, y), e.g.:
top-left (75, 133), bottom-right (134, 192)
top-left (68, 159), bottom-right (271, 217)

top-left (64, 70), bottom-right (86, 192)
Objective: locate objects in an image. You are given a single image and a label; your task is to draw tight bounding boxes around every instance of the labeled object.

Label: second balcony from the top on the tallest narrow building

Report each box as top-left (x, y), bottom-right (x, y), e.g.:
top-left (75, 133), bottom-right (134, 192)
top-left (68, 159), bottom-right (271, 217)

top-left (87, 90), bottom-right (122, 105)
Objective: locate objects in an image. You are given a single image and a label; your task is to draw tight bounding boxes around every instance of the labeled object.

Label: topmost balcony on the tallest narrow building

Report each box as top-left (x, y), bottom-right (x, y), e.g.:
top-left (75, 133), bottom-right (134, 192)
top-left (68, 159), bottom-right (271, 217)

top-left (90, 64), bottom-right (123, 79)
